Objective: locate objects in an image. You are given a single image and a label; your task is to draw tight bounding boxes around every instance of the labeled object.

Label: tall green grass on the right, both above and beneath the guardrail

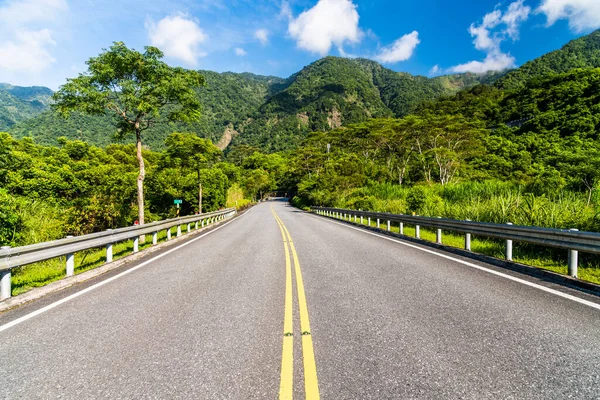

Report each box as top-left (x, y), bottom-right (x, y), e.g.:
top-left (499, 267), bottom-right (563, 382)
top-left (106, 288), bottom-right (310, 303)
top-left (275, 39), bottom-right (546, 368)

top-left (335, 181), bottom-right (600, 284)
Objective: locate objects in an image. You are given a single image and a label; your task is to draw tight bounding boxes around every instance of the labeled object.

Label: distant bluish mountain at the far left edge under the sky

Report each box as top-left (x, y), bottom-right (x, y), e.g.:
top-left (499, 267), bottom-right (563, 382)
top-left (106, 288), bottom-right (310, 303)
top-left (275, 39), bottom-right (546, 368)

top-left (0, 83), bottom-right (52, 131)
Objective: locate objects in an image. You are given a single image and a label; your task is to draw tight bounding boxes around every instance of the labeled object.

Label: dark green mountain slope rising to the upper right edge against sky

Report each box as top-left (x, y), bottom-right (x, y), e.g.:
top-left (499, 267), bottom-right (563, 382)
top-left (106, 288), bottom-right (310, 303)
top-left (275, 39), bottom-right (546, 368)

top-left (495, 29), bottom-right (600, 90)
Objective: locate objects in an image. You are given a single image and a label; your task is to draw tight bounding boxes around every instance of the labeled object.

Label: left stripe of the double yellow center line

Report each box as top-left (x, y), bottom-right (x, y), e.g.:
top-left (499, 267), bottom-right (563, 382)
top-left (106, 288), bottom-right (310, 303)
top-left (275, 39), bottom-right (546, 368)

top-left (271, 207), bottom-right (294, 400)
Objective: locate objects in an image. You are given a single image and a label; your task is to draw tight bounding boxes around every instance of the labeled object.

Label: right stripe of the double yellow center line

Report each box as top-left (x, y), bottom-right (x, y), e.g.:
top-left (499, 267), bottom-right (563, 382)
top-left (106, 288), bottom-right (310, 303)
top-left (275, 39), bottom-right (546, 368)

top-left (271, 207), bottom-right (320, 400)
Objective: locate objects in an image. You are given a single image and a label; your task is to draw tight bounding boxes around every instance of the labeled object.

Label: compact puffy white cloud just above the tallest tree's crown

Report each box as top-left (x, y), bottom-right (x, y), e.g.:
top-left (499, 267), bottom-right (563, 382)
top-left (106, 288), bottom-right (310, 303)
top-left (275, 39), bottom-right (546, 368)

top-left (146, 13), bottom-right (207, 66)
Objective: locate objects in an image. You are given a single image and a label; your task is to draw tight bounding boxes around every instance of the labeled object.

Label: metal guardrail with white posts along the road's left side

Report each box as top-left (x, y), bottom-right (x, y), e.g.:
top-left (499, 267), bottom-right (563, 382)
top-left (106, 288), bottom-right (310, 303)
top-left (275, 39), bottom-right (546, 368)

top-left (0, 208), bottom-right (236, 300)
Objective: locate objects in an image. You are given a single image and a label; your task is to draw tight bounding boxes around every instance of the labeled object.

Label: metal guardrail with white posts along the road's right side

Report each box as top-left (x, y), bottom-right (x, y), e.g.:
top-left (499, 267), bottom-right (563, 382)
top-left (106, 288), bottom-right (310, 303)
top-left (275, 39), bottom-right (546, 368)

top-left (312, 207), bottom-right (600, 278)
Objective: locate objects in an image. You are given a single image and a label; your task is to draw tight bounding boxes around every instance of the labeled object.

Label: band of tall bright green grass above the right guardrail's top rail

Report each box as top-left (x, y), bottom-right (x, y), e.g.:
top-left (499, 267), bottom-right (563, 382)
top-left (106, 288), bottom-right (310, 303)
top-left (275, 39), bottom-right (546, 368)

top-left (346, 181), bottom-right (600, 231)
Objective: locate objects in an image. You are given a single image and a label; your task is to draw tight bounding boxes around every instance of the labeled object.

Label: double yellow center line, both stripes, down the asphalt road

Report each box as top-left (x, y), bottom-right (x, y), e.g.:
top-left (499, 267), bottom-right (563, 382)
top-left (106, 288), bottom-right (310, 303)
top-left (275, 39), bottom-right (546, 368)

top-left (271, 206), bottom-right (320, 400)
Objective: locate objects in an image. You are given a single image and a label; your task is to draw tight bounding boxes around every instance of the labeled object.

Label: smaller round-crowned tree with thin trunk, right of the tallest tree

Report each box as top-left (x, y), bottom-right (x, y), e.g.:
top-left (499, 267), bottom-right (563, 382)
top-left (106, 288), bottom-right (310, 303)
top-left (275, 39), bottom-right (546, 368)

top-left (165, 133), bottom-right (222, 213)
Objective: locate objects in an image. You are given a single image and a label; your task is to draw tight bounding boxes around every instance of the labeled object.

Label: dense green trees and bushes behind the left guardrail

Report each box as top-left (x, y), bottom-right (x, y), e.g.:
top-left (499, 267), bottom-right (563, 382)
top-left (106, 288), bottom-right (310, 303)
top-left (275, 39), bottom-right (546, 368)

top-left (0, 133), bottom-right (284, 246)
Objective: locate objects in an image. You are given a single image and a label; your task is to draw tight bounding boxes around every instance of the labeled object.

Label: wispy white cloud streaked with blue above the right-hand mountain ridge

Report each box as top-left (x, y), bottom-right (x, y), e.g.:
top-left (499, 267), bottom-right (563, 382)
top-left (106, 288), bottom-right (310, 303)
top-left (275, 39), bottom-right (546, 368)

top-left (450, 0), bottom-right (531, 73)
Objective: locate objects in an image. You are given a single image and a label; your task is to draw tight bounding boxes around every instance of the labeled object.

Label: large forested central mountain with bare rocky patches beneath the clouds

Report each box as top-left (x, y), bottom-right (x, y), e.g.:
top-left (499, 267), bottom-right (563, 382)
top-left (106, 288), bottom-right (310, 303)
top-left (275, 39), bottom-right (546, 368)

top-left (234, 57), bottom-right (496, 151)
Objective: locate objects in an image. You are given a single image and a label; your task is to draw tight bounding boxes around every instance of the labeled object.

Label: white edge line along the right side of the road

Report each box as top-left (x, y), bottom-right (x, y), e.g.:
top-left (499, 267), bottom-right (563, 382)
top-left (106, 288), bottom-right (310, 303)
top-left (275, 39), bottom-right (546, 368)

top-left (312, 214), bottom-right (600, 310)
